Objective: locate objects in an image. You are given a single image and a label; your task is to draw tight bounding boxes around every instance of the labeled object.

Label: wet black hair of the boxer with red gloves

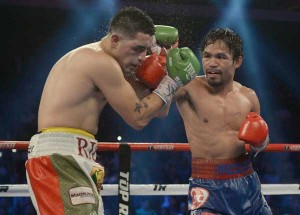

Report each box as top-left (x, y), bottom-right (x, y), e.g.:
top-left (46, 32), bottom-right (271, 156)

top-left (200, 28), bottom-right (243, 60)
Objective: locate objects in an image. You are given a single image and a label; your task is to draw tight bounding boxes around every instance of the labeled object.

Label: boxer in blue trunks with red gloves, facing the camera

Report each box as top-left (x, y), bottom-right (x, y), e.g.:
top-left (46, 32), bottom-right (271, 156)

top-left (174, 28), bottom-right (272, 215)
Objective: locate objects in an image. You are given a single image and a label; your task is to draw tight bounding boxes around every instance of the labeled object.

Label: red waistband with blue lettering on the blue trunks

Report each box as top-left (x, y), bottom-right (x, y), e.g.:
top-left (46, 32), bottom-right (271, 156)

top-left (192, 154), bottom-right (253, 180)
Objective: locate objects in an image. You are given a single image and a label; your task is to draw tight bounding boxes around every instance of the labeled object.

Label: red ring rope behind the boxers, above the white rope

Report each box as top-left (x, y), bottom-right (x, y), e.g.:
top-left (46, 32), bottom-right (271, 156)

top-left (0, 140), bottom-right (300, 152)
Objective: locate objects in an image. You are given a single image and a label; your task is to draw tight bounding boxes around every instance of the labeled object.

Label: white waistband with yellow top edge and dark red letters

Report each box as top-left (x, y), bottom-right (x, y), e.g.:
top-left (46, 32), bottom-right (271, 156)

top-left (28, 127), bottom-right (97, 160)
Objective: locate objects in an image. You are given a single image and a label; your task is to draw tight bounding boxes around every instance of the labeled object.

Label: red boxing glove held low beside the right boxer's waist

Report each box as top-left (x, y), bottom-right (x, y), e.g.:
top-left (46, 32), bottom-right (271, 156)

top-left (238, 112), bottom-right (269, 151)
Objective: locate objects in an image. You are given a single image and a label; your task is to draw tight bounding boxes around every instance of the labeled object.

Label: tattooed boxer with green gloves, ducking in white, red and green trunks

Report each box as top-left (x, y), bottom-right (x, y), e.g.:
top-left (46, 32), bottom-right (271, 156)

top-left (26, 7), bottom-right (200, 215)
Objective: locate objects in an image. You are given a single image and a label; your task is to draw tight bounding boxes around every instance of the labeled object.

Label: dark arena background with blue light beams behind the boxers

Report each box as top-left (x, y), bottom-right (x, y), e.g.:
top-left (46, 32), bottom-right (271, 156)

top-left (0, 0), bottom-right (300, 214)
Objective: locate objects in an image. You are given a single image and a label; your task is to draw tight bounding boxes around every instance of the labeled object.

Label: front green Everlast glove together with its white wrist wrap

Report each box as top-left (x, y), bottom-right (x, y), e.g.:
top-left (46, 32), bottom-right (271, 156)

top-left (153, 47), bottom-right (200, 104)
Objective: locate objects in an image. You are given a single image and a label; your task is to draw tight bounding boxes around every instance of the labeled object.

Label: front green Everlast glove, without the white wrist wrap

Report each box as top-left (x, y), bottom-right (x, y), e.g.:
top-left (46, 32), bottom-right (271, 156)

top-left (167, 47), bottom-right (200, 86)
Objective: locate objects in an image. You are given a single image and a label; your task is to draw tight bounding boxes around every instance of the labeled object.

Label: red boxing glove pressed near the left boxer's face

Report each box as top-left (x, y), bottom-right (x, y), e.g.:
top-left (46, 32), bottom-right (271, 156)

top-left (135, 54), bottom-right (166, 89)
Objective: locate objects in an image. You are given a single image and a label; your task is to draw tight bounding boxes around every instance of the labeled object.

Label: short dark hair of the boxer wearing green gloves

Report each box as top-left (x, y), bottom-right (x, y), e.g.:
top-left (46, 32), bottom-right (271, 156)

top-left (108, 7), bottom-right (155, 37)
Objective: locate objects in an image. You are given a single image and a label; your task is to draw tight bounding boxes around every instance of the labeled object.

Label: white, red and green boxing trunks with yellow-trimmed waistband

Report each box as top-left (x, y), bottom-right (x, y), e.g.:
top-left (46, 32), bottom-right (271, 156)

top-left (25, 128), bottom-right (104, 215)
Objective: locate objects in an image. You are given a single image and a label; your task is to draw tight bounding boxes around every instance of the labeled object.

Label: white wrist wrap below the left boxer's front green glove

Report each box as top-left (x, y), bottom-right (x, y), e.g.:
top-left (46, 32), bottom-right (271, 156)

top-left (153, 75), bottom-right (179, 105)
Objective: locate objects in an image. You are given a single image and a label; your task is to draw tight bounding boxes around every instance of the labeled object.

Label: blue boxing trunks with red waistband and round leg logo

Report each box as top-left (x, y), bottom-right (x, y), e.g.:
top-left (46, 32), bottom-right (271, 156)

top-left (188, 155), bottom-right (272, 215)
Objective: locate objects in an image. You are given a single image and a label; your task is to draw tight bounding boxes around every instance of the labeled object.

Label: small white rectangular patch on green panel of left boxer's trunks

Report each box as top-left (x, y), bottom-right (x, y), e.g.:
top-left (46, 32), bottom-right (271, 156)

top-left (69, 187), bottom-right (96, 205)
